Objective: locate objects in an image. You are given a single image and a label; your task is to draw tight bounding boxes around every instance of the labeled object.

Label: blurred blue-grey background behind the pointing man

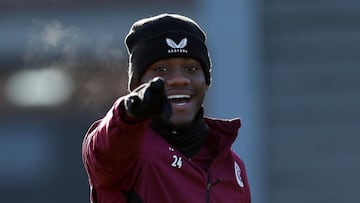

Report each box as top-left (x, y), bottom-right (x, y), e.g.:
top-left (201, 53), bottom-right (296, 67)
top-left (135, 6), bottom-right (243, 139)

top-left (0, 0), bottom-right (360, 203)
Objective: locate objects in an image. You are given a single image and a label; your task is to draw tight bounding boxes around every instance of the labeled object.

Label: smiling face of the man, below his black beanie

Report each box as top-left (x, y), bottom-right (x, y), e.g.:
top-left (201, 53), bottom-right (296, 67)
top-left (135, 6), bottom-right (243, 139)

top-left (140, 58), bottom-right (209, 126)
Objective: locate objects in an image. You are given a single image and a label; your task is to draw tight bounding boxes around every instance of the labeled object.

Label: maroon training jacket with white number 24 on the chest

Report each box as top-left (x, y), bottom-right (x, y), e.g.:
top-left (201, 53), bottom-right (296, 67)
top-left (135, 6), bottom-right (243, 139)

top-left (82, 98), bottom-right (251, 203)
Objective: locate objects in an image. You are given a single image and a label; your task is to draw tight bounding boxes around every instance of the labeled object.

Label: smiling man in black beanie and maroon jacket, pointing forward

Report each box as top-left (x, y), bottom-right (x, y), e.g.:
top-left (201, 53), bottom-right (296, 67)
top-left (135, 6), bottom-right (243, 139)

top-left (82, 14), bottom-right (251, 203)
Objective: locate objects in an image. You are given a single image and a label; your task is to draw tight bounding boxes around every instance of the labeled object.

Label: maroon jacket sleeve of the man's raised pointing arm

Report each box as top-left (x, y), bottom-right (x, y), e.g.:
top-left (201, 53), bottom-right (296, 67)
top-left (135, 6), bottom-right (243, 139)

top-left (82, 97), bottom-right (150, 187)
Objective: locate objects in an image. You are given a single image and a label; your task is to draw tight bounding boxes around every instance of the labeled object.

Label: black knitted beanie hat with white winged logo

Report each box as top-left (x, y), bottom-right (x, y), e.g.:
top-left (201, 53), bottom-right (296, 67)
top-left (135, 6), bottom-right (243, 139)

top-left (125, 13), bottom-right (211, 91)
